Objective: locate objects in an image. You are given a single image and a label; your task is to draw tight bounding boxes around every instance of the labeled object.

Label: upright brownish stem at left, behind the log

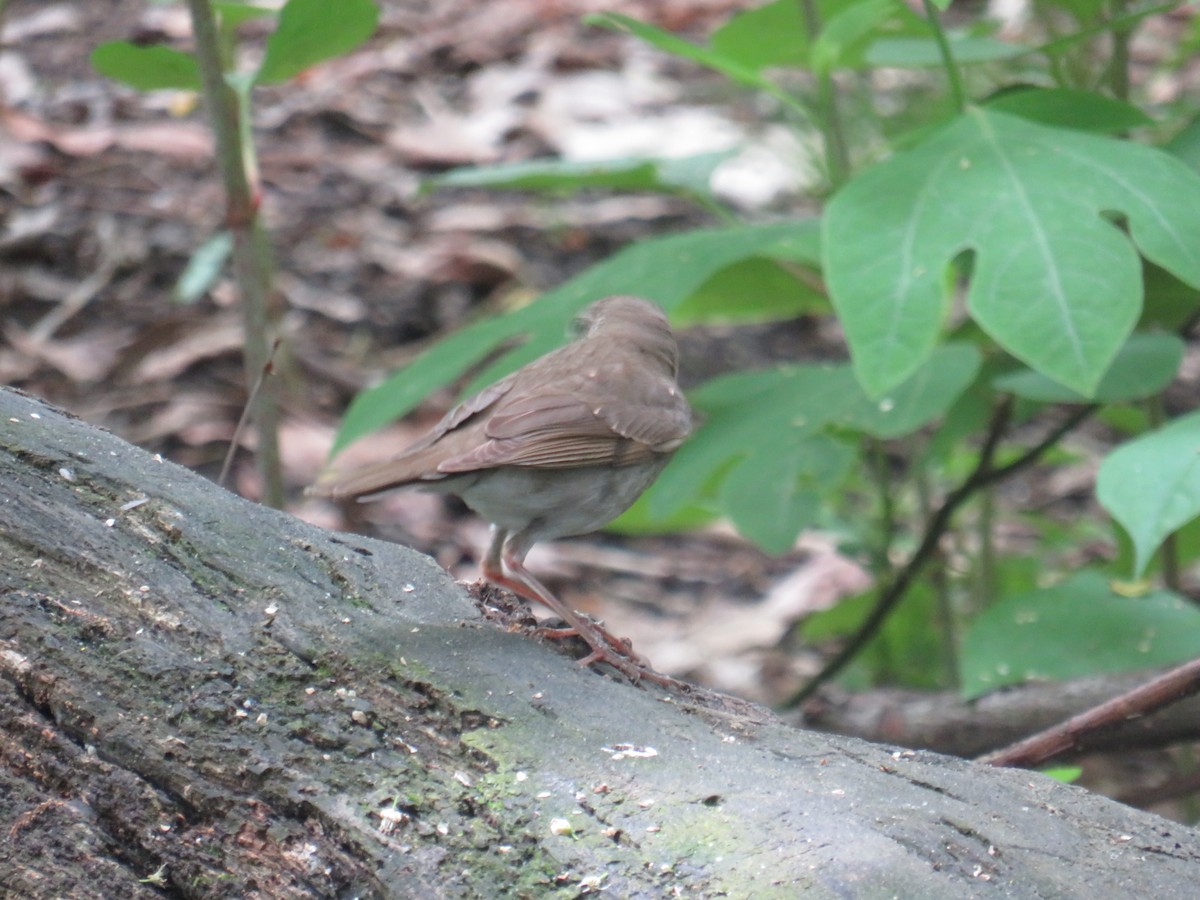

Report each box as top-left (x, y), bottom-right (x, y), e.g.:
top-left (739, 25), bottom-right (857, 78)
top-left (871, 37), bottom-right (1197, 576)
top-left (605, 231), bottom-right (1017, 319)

top-left (187, 0), bottom-right (283, 508)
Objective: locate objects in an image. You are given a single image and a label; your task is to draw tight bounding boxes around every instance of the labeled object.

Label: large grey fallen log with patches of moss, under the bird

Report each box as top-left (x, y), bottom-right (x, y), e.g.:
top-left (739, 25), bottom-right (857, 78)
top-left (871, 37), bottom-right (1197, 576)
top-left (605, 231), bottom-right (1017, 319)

top-left (0, 390), bottom-right (1200, 899)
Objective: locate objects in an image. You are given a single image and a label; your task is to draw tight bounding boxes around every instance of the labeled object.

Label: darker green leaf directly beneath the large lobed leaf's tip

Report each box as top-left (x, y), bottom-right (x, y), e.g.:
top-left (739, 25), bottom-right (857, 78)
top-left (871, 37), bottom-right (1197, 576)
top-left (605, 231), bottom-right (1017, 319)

top-left (992, 334), bottom-right (1183, 403)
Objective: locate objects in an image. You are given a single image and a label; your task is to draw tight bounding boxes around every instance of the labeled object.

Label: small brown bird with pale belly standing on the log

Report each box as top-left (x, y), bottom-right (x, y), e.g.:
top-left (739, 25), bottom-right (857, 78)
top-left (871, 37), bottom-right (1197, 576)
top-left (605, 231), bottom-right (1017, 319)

top-left (312, 296), bottom-right (692, 683)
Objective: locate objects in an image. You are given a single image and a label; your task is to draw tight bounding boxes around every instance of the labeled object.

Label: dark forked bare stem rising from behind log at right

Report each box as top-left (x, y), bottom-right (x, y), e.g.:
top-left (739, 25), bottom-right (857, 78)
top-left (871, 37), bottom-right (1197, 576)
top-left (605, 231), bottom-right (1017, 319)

top-left (781, 397), bottom-right (1098, 709)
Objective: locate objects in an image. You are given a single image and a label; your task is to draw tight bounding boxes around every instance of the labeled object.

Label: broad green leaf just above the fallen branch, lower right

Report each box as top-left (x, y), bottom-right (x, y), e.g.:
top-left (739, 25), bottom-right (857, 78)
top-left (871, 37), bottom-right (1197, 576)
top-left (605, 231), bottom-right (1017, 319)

top-left (961, 571), bottom-right (1200, 700)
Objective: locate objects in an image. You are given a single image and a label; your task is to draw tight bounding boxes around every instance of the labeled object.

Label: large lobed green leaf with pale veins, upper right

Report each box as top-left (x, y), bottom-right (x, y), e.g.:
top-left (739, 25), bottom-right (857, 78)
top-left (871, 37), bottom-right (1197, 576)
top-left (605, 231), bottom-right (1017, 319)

top-left (822, 109), bottom-right (1200, 395)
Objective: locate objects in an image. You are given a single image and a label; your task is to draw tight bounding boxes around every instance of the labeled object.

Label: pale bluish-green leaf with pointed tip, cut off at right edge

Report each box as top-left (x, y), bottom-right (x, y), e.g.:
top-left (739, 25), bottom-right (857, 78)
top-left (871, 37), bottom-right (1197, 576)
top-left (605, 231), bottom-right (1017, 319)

top-left (1096, 413), bottom-right (1200, 577)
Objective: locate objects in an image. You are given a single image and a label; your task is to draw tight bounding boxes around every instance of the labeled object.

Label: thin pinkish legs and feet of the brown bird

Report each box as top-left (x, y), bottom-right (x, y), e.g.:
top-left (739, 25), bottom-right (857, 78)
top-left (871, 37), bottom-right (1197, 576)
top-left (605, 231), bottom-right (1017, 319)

top-left (482, 526), bottom-right (680, 686)
